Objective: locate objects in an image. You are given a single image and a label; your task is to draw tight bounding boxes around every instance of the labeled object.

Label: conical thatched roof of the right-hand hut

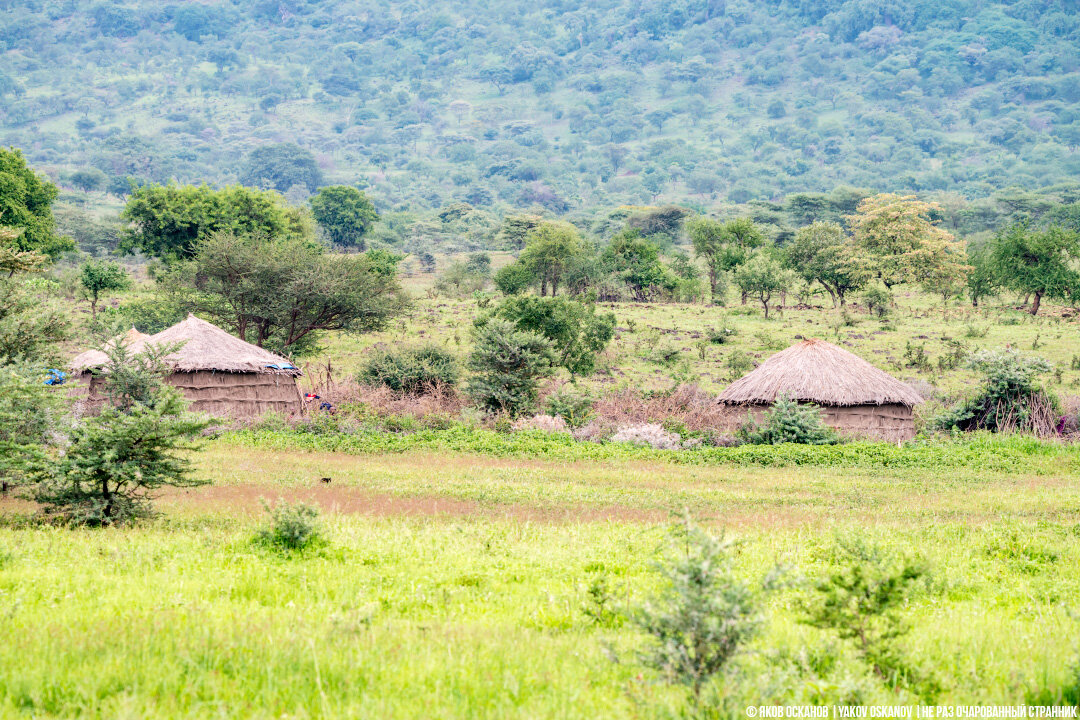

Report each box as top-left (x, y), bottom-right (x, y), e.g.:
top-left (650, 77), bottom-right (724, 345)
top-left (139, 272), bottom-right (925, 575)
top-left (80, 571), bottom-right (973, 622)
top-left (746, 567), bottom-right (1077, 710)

top-left (719, 340), bottom-right (922, 406)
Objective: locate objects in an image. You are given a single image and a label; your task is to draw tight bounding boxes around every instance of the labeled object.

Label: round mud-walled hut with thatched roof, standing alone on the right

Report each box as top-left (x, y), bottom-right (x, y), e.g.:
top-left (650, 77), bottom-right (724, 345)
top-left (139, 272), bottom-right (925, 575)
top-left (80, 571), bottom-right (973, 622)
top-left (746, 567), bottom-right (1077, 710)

top-left (718, 340), bottom-right (922, 443)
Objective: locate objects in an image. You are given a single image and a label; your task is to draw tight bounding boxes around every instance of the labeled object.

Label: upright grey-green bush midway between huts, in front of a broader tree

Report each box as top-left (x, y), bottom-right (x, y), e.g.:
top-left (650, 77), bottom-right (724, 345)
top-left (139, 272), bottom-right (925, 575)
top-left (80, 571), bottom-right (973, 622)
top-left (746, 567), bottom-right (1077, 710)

top-left (468, 318), bottom-right (554, 416)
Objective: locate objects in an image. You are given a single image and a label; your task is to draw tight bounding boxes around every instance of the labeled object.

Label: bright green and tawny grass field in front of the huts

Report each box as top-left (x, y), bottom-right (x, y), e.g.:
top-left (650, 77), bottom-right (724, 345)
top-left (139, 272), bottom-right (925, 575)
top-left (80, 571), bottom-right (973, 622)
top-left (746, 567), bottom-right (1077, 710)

top-left (0, 434), bottom-right (1080, 718)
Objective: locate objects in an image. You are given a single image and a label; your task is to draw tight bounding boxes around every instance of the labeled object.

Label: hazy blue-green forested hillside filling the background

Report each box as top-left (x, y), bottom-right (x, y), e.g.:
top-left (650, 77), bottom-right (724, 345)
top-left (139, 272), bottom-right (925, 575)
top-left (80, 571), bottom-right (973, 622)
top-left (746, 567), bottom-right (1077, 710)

top-left (0, 0), bottom-right (1080, 212)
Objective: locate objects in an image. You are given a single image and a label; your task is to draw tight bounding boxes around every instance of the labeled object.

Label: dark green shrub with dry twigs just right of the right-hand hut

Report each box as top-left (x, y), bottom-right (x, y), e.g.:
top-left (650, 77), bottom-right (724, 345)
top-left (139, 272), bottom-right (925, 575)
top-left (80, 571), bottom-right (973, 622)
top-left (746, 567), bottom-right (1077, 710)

top-left (931, 350), bottom-right (1058, 435)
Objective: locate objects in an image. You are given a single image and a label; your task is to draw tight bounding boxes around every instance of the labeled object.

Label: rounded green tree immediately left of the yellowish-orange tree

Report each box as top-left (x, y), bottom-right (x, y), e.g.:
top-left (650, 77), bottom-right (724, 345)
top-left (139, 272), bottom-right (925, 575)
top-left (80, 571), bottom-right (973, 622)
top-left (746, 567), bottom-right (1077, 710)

top-left (784, 221), bottom-right (870, 308)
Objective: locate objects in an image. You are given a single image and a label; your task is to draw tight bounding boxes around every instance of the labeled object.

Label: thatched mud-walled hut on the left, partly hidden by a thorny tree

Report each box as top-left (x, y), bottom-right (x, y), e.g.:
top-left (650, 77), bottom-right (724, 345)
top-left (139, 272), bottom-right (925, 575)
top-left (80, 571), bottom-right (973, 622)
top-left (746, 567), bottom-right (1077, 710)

top-left (71, 315), bottom-right (303, 418)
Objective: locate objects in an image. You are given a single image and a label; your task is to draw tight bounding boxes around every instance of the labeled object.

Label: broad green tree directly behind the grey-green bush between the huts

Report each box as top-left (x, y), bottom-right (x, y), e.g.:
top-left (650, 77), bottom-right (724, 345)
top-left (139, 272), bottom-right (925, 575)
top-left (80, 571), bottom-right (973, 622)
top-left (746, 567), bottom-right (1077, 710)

top-left (490, 295), bottom-right (615, 376)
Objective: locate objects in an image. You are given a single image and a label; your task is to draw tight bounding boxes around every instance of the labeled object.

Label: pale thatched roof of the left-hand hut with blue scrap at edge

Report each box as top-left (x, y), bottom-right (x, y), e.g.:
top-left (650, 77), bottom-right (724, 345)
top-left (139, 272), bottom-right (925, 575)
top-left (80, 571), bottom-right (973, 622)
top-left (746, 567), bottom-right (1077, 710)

top-left (71, 315), bottom-right (300, 376)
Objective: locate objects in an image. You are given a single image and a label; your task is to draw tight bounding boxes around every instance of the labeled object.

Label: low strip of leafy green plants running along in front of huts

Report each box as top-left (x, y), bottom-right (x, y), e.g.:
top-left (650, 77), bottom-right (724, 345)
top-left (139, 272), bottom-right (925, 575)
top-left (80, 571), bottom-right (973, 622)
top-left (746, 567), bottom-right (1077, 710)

top-left (216, 426), bottom-right (1080, 475)
